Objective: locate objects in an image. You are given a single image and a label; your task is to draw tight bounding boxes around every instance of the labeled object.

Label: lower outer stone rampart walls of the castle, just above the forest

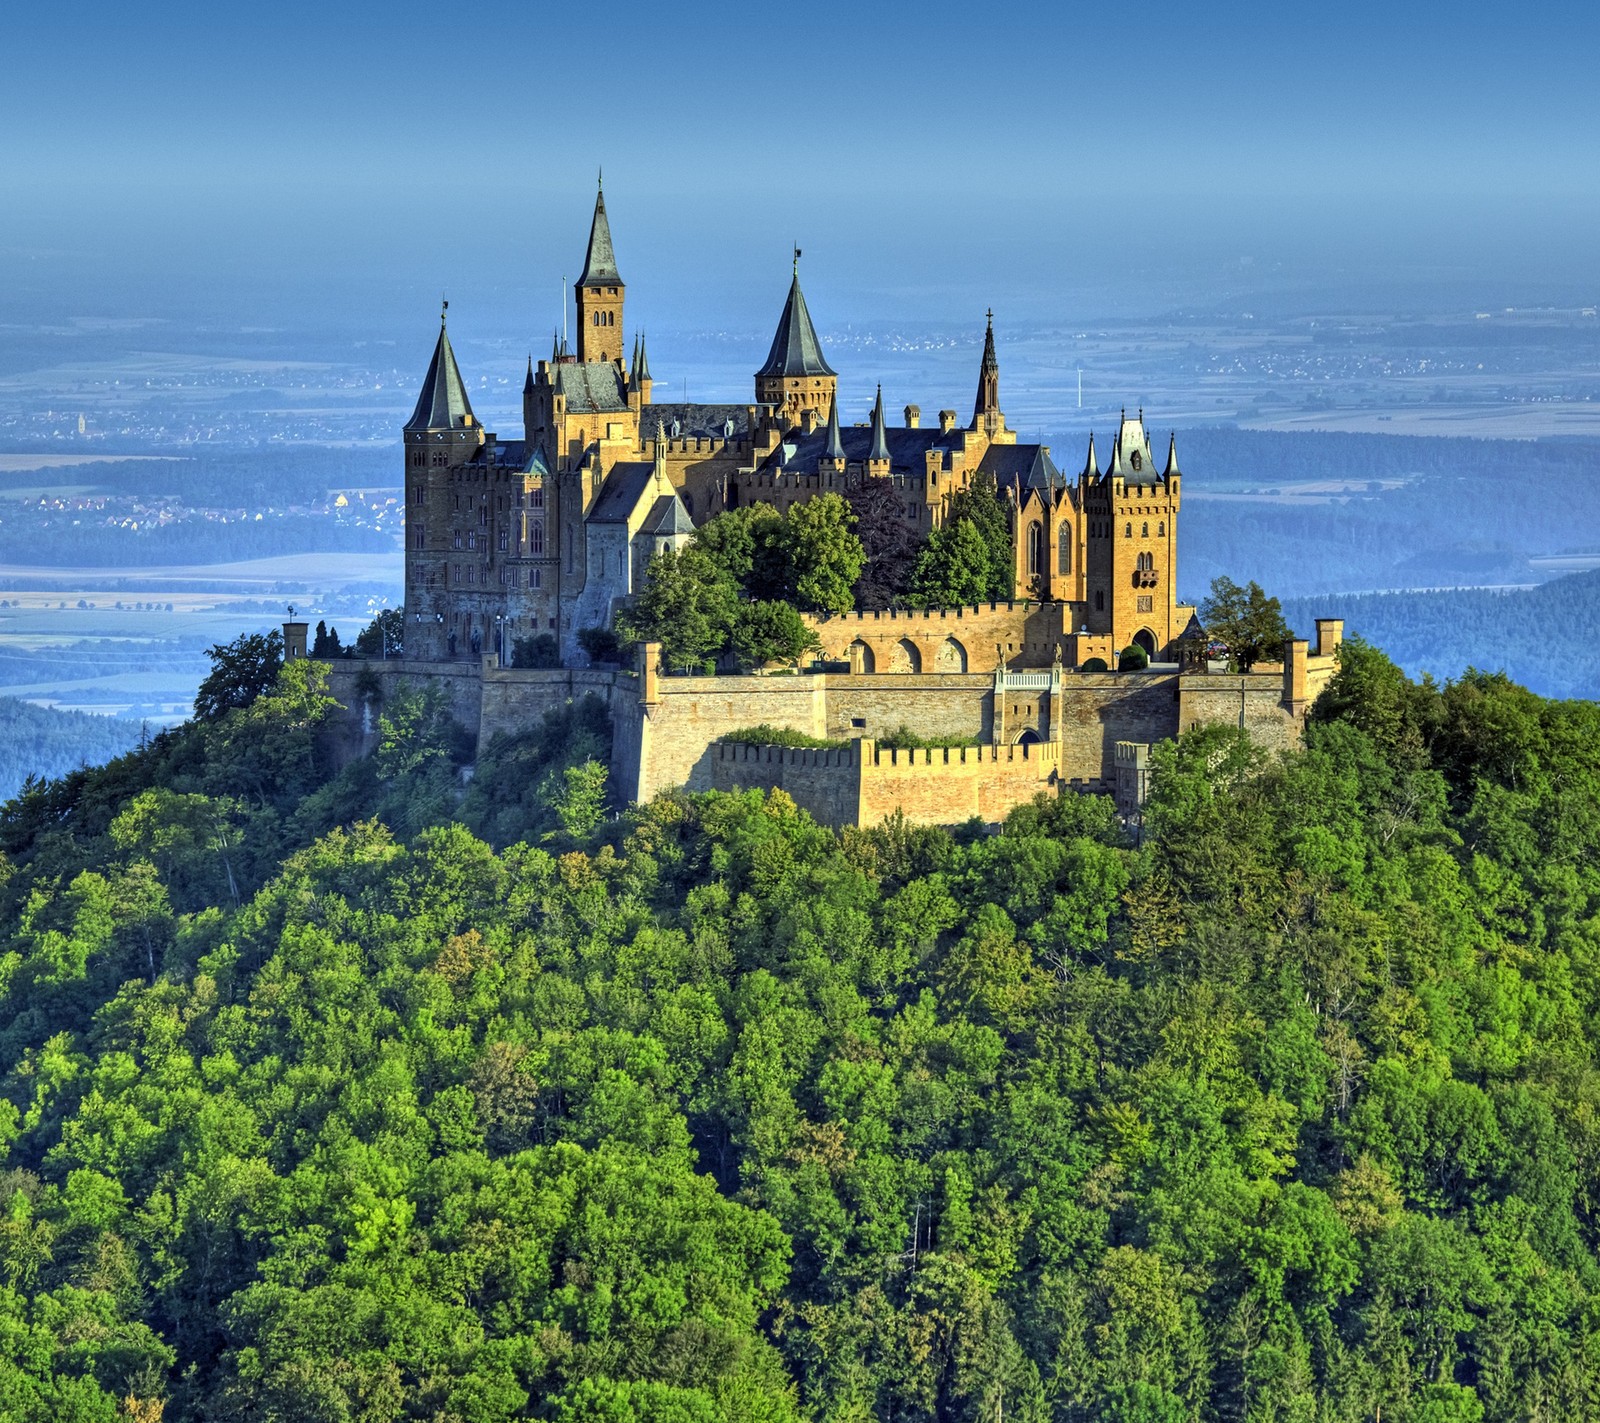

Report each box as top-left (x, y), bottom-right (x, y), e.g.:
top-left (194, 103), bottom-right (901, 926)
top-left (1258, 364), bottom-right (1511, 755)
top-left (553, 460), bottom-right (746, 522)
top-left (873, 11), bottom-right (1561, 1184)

top-left (312, 624), bottom-right (1341, 824)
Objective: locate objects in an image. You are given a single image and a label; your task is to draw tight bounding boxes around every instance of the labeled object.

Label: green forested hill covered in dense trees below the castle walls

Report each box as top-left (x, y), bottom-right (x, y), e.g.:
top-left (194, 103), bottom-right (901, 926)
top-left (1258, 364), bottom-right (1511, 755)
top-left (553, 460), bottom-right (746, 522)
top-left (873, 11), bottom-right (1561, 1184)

top-left (0, 643), bottom-right (1600, 1423)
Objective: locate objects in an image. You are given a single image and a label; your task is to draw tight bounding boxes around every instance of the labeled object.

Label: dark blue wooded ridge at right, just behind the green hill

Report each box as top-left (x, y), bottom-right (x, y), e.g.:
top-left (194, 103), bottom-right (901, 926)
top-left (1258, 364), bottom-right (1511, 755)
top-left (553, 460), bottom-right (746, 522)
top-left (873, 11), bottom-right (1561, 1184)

top-left (1283, 573), bottom-right (1600, 699)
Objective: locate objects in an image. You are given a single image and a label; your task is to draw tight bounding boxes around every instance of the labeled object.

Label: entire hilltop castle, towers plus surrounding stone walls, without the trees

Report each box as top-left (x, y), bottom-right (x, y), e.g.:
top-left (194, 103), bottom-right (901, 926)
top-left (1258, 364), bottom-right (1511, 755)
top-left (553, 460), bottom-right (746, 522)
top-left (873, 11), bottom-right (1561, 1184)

top-left (321, 179), bottom-right (1342, 824)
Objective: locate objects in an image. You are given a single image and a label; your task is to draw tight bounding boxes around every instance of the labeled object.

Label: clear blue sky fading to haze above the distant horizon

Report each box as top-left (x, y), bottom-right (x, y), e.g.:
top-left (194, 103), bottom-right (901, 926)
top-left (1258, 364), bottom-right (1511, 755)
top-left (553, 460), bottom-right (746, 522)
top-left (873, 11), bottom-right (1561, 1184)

top-left (0, 0), bottom-right (1600, 327)
